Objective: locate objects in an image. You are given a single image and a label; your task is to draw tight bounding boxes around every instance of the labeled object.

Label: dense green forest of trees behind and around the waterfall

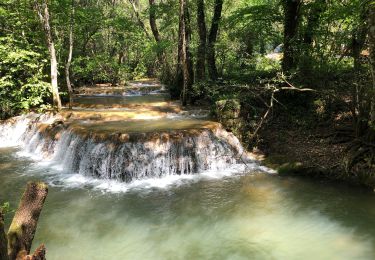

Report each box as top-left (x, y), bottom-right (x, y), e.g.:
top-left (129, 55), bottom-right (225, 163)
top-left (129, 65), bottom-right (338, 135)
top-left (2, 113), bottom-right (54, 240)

top-left (0, 0), bottom-right (375, 187)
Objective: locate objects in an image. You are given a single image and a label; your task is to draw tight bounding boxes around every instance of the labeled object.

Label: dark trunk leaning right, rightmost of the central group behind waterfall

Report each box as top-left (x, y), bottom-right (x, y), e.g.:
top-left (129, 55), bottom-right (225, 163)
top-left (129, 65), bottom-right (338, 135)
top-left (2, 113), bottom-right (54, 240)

top-left (207, 0), bottom-right (223, 80)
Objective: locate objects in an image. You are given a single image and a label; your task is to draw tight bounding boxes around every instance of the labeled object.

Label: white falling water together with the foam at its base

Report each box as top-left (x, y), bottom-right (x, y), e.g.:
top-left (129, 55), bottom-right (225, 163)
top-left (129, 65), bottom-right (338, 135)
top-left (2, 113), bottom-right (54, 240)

top-left (0, 114), bottom-right (267, 193)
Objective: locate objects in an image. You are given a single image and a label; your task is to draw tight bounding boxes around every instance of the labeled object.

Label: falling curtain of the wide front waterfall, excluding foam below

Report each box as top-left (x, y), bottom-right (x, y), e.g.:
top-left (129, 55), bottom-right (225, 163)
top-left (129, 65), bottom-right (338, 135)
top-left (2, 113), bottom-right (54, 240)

top-left (0, 114), bottom-right (254, 182)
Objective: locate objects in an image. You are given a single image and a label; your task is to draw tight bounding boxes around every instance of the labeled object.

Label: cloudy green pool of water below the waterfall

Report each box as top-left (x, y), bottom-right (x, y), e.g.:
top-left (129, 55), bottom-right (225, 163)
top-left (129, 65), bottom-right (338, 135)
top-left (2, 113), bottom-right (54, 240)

top-left (0, 149), bottom-right (375, 259)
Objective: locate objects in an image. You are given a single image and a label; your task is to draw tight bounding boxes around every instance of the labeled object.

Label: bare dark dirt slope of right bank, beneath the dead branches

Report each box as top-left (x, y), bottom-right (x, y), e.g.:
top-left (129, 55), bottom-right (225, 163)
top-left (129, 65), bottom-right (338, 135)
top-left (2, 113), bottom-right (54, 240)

top-left (258, 110), bottom-right (375, 190)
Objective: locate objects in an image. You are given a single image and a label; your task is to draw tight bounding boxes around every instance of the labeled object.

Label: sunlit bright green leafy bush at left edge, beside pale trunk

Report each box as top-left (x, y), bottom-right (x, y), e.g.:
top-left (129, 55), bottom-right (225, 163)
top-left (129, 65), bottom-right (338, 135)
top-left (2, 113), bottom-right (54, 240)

top-left (0, 37), bottom-right (50, 118)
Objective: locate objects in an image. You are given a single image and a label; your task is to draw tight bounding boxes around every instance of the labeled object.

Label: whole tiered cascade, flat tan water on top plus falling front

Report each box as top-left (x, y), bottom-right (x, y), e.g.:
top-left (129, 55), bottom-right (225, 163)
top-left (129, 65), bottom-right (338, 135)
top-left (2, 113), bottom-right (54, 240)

top-left (0, 82), bottom-right (251, 182)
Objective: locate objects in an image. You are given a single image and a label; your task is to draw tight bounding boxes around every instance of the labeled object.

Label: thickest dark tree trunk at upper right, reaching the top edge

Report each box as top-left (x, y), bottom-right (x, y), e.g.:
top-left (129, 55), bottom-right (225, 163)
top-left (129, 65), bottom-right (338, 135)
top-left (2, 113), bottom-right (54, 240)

top-left (282, 0), bottom-right (301, 72)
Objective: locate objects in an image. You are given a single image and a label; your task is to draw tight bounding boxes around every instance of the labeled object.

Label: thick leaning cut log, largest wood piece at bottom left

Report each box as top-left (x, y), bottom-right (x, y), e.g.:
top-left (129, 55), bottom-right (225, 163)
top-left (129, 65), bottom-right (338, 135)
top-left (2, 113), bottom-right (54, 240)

top-left (8, 182), bottom-right (48, 260)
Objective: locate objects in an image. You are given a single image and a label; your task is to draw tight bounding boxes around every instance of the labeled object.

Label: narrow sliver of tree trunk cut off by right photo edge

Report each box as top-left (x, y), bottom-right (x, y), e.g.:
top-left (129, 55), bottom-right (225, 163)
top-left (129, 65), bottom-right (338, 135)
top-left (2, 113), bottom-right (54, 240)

top-left (369, 3), bottom-right (375, 125)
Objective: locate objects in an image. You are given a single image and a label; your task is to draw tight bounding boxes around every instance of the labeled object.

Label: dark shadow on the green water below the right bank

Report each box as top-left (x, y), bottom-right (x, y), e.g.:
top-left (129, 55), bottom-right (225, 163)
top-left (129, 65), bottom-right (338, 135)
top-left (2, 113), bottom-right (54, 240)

top-left (270, 174), bottom-right (375, 243)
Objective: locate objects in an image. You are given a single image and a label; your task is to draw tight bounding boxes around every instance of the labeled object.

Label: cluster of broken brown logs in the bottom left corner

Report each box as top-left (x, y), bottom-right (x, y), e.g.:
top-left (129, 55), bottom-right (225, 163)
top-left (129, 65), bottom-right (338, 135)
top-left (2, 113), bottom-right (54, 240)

top-left (0, 182), bottom-right (48, 260)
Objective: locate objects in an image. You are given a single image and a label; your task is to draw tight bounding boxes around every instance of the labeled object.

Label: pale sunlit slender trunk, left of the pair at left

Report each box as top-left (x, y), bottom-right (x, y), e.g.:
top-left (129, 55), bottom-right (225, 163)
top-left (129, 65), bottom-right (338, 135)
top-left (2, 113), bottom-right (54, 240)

top-left (35, 0), bottom-right (61, 110)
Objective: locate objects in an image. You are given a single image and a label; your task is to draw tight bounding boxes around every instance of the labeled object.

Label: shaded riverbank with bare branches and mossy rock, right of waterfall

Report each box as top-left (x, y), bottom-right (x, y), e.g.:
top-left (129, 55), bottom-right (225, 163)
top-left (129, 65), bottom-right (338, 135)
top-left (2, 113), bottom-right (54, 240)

top-left (209, 81), bottom-right (375, 190)
